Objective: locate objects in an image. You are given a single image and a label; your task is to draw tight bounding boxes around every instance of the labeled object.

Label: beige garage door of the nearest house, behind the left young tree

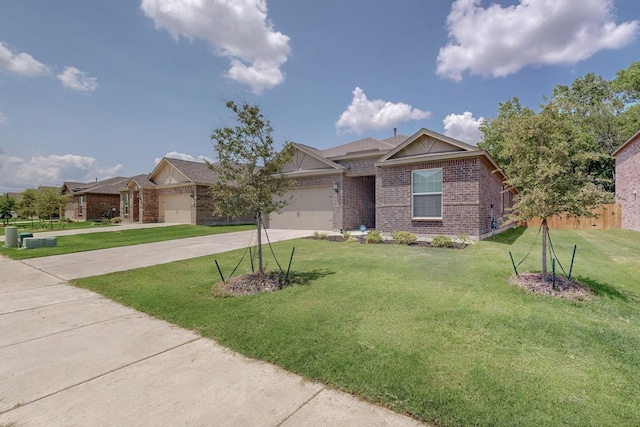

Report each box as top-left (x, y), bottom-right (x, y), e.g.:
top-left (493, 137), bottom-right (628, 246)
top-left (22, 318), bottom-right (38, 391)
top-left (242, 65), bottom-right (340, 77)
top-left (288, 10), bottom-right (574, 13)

top-left (269, 187), bottom-right (333, 231)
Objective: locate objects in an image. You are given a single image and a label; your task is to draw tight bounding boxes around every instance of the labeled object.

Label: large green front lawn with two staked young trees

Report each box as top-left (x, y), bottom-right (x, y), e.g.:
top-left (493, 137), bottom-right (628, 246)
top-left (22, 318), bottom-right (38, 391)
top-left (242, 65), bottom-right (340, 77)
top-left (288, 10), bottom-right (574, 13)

top-left (75, 230), bottom-right (640, 426)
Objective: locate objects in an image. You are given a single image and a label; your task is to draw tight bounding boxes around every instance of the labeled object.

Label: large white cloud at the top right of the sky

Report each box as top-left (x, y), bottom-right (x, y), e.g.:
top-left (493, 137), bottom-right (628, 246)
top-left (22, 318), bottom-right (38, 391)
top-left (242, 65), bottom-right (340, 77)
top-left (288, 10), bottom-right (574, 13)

top-left (437, 0), bottom-right (640, 81)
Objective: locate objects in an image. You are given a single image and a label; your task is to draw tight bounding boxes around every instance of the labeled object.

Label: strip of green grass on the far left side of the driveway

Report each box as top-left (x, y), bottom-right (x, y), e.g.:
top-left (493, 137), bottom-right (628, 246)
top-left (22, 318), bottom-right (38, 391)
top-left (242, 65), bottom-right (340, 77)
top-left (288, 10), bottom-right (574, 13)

top-left (0, 225), bottom-right (255, 260)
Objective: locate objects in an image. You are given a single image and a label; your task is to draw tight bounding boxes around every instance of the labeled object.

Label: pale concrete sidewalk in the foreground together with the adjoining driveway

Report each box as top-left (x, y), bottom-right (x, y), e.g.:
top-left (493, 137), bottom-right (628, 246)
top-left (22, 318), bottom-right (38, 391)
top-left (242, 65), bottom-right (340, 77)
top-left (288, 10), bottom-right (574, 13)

top-left (0, 230), bottom-right (430, 427)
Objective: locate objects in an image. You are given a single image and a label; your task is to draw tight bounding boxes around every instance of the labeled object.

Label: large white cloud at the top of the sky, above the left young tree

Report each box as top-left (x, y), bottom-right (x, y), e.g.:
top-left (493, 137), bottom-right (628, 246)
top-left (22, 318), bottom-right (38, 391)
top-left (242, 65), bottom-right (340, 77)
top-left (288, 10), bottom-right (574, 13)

top-left (141, 0), bottom-right (291, 94)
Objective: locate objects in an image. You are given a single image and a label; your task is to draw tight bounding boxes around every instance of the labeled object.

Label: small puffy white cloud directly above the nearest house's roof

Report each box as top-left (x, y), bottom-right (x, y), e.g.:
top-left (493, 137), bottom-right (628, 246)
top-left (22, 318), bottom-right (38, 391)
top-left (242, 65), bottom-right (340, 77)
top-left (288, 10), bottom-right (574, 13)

top-left (336, 87), bottom-right (431, 137)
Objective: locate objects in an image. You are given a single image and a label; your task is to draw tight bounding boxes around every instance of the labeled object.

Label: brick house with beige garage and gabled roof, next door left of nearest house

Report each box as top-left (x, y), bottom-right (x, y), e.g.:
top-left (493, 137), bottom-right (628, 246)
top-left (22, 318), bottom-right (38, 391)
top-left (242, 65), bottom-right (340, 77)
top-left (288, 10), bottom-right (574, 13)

top-left (120, 157), bottom-right (252, 225)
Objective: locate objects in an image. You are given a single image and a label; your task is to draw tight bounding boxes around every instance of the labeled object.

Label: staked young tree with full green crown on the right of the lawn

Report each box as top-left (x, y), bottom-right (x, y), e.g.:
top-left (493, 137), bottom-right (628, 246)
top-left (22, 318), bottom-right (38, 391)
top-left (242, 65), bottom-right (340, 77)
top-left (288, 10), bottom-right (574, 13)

top-left (483, 102), bottom-right (613, 281)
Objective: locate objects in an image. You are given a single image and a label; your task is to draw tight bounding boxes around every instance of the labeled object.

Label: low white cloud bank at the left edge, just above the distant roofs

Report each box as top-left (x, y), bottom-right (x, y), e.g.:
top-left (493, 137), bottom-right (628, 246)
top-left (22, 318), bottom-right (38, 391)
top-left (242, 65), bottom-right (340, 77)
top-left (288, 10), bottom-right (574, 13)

top-left (0, 150), bottom-right (124, 192)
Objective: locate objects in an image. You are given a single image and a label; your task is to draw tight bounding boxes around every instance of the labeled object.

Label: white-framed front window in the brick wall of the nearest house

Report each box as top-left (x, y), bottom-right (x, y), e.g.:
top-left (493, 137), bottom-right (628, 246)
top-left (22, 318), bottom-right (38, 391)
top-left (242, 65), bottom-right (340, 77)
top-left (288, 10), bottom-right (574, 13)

top-left (411, 169), bottom-right (442, 219)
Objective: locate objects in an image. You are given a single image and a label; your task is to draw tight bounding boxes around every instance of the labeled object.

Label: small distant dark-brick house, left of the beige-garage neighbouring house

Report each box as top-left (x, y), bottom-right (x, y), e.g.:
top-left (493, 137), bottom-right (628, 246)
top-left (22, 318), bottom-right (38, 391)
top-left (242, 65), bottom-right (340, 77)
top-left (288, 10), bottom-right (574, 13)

top-left (61, 177), bottom-right (129, 221)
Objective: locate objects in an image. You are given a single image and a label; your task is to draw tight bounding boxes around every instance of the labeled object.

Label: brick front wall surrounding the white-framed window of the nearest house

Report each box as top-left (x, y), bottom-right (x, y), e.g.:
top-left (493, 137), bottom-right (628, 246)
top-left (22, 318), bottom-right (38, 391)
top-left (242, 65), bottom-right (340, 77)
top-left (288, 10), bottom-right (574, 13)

top-left (376, 158), bottom-right (501, 239)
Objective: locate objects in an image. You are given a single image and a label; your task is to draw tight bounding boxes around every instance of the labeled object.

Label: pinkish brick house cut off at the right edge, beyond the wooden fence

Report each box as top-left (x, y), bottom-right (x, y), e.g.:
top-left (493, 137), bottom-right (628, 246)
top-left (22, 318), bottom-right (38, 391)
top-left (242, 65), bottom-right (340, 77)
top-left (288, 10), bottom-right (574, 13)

top-left (613, 131), bottom-right (640, 231)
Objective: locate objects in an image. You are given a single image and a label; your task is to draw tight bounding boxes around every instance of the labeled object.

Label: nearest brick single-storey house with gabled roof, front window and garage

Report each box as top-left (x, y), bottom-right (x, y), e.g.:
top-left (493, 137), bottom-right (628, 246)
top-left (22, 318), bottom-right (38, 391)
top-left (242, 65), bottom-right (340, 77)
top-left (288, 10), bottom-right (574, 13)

top-left (269, 129), bottom-right (513, 239)
